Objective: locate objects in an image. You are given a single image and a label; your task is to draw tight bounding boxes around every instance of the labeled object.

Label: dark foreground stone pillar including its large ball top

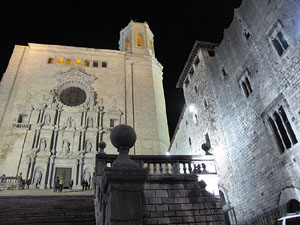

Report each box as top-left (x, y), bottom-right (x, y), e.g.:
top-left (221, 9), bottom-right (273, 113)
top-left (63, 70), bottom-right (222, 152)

top-left (97, 125), bottom-right (147, 225)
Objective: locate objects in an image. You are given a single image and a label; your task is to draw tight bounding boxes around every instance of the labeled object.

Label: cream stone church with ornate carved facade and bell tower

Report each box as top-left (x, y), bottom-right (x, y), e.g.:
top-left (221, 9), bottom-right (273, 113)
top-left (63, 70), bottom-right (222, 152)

top-left (0, 21), bottom-right (169, 188)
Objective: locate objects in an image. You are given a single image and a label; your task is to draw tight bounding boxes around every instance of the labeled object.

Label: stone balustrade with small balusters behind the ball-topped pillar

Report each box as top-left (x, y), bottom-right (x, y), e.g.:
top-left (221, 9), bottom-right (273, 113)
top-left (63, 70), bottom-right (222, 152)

top-left (96, 154), bottom-right (217, 176)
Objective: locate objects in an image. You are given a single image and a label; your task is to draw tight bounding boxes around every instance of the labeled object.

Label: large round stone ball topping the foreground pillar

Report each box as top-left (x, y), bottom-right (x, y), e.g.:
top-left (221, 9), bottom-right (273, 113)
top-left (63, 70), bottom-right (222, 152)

top-left (110, 124), bottom-right (136, 149)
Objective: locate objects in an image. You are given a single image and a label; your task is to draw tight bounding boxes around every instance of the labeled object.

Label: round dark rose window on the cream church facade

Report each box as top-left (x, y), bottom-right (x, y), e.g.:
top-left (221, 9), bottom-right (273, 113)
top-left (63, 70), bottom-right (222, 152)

top-left (60, 87), bottom-right (86, 106)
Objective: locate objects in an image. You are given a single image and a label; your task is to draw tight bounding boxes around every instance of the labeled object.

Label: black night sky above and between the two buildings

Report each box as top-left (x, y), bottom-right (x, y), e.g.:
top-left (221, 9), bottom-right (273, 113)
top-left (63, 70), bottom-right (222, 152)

top-left (0, 0), bottom-right (241, 136)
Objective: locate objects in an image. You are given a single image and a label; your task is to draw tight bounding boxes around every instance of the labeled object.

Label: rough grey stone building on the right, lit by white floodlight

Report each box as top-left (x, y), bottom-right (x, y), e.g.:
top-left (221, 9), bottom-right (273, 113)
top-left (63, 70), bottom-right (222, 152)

top-left (169, 0), bottom-right (300, 224)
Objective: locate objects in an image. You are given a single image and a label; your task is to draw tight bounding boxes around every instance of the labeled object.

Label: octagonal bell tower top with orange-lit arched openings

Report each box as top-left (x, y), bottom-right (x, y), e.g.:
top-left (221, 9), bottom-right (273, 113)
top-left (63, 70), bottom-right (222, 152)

top-left (119, 20), bottom-right (155, 56)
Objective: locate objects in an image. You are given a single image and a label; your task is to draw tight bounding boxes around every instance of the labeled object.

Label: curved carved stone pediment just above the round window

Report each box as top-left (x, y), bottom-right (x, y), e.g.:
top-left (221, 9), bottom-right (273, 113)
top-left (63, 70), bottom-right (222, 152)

top-left (56, 68), bottom-right (97, 84)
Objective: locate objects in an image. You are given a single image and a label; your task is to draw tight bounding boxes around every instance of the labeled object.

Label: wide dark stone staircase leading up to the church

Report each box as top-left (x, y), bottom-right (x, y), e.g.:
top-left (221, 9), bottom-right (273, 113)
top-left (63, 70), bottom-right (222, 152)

top-left (0, 195), bottom-right (95, 225)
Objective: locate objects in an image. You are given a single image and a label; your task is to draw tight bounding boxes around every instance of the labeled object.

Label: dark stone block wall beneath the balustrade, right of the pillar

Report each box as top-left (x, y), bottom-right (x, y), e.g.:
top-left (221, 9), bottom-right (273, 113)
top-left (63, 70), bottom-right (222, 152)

top-left (143, 175), bottom-right (225, 225)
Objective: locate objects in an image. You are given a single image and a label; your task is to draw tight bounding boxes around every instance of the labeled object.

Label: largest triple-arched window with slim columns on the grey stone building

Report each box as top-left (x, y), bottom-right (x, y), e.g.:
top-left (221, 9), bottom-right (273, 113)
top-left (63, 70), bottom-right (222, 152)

top-left (268, 106), bottom-right (298, 153)
